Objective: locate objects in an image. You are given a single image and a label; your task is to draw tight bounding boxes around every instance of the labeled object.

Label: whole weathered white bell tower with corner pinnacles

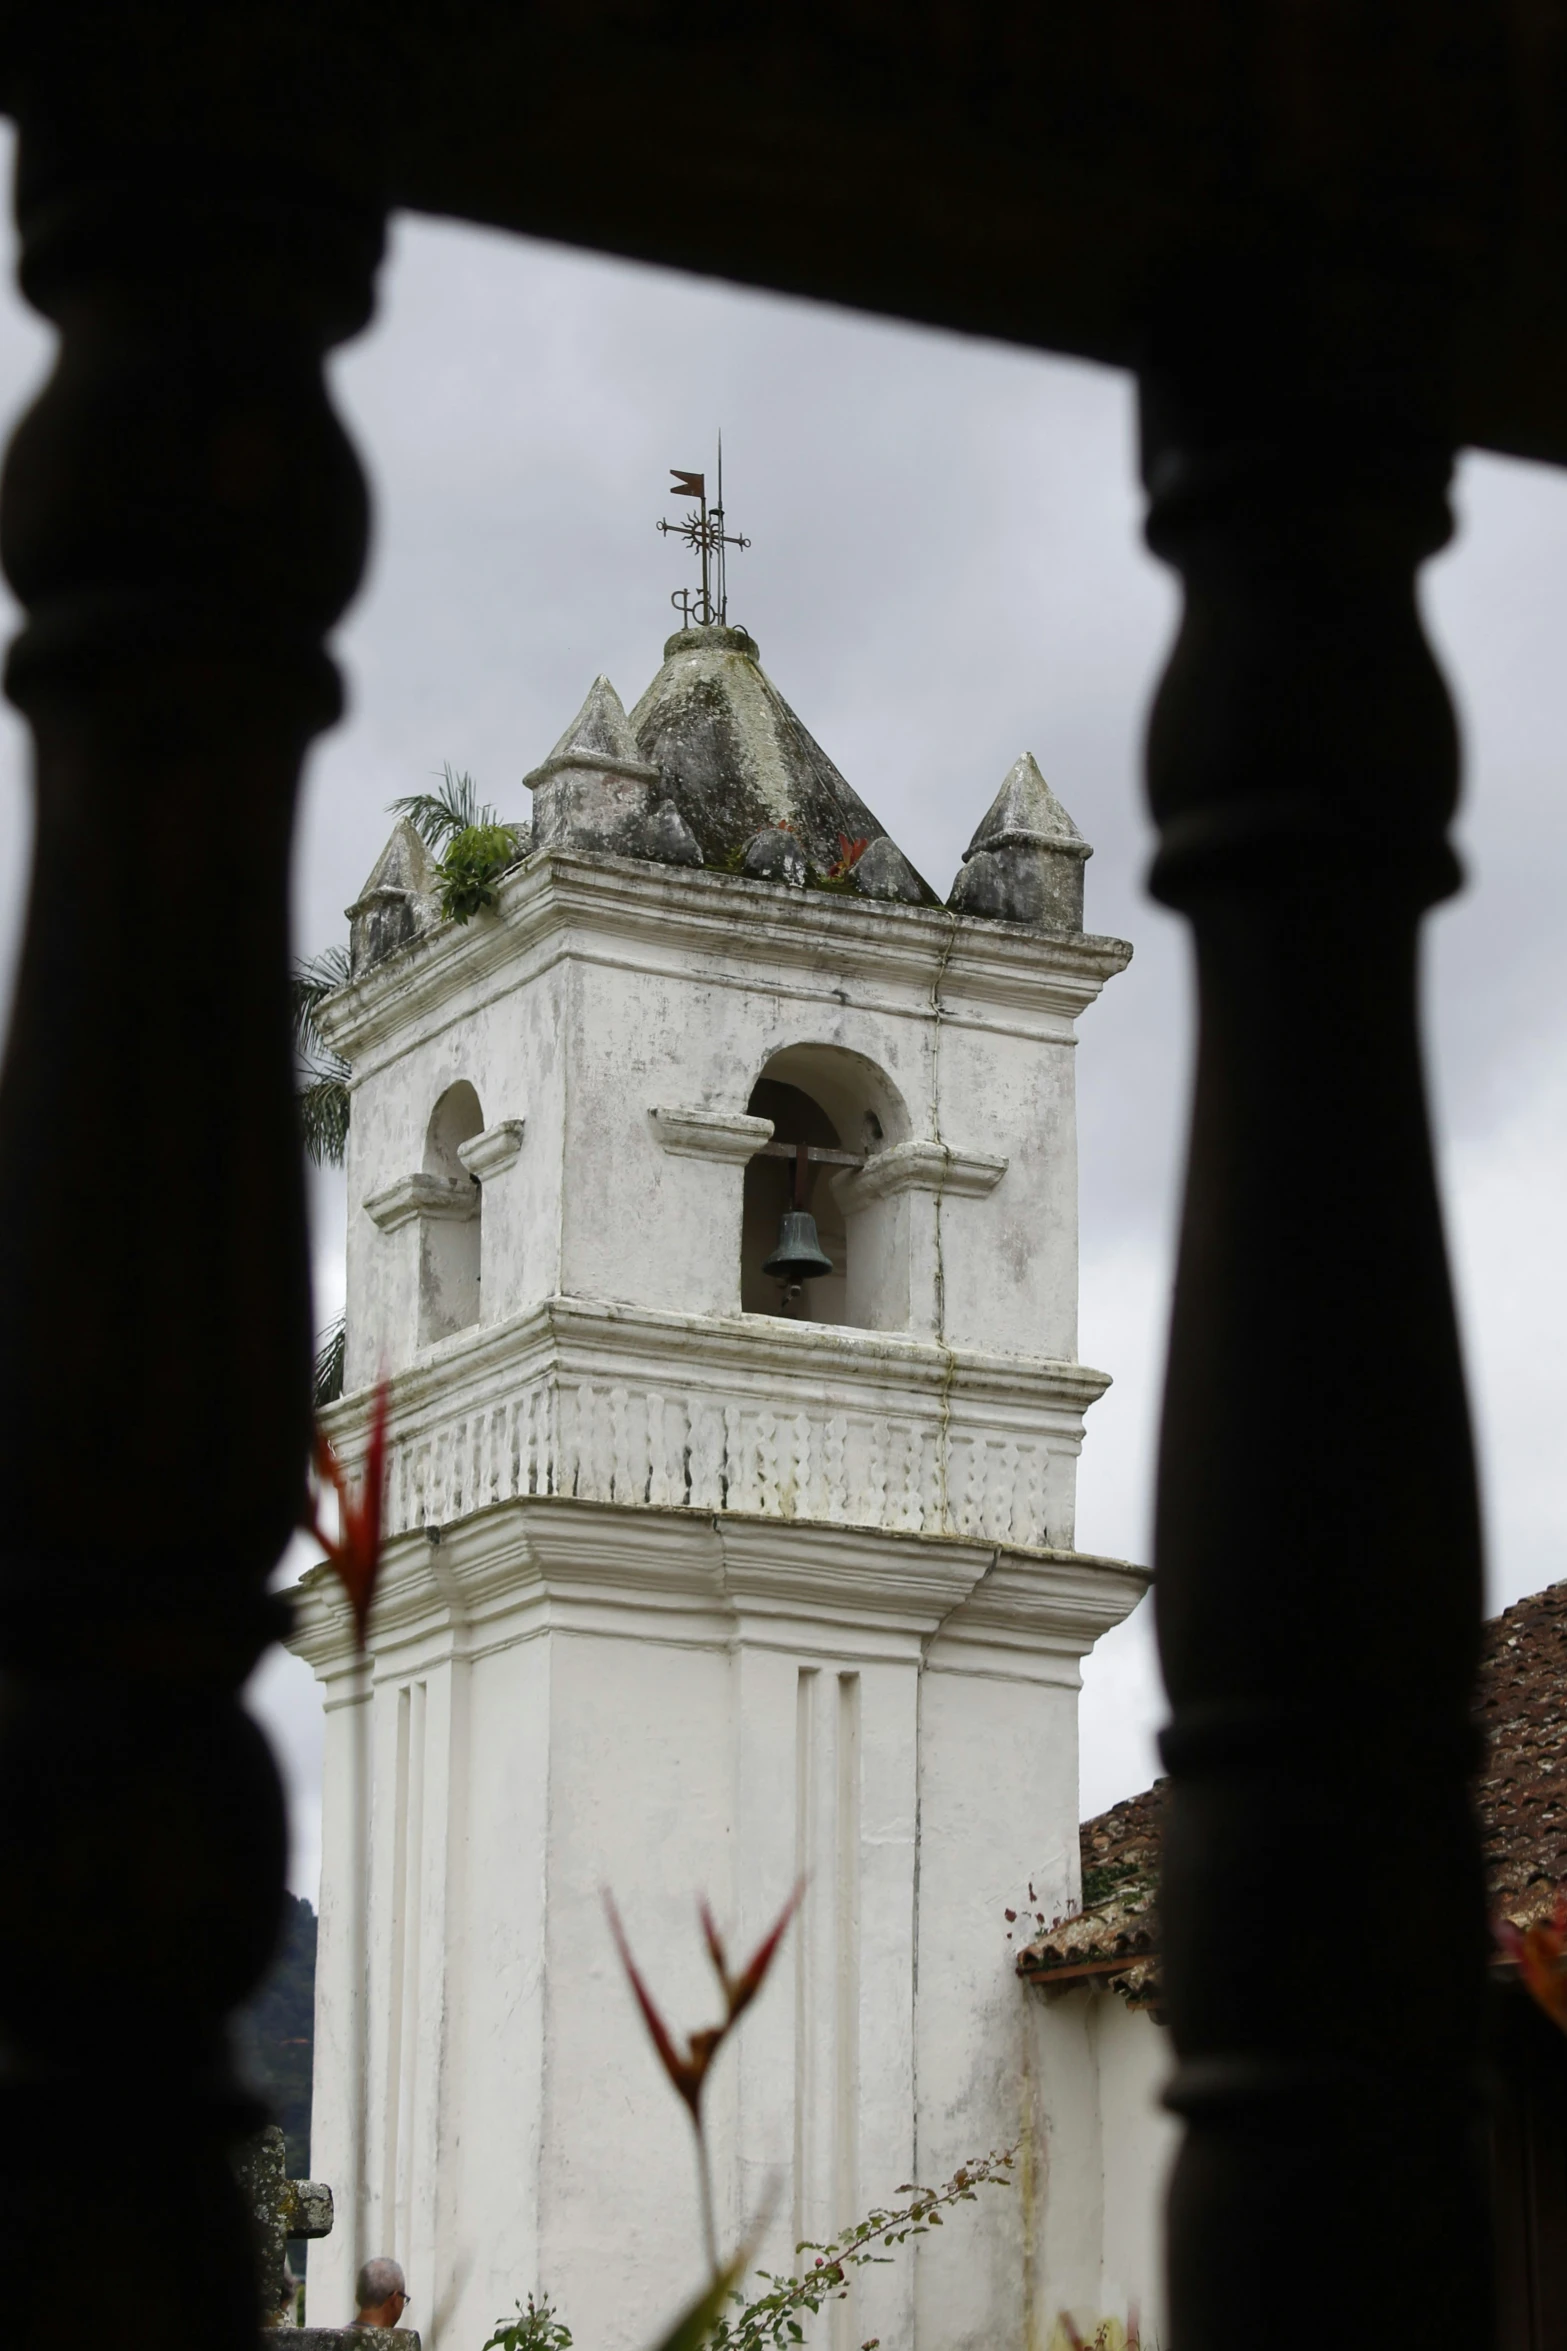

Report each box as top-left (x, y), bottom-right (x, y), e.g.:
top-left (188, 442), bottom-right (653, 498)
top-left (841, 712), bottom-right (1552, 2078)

top-left (294, 625), bottom-right (1144, 2351)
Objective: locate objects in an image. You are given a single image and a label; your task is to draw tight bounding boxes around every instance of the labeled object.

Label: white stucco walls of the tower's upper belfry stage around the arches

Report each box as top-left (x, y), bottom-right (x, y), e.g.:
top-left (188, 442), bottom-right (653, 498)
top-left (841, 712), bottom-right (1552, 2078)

top-left (324, 851), bottom-right (1128, 1389)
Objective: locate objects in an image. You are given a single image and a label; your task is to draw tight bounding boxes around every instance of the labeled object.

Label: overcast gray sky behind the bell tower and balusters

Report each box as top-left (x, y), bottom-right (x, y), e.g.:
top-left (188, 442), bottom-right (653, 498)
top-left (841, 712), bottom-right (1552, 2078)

top-left (0, 137), bottom-right (1567, 1893)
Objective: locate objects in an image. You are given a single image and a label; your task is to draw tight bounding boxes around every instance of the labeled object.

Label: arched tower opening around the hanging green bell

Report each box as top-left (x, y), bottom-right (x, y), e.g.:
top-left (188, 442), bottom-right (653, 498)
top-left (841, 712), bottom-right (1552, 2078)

top-left (740, 1044), bottom-right (909, 1328)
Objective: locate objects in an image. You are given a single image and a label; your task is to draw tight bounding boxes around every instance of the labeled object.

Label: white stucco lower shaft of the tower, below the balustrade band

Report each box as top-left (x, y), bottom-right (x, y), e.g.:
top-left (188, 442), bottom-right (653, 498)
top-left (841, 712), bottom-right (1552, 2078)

top-left (296, 1498), bottom-right (1137, 2351)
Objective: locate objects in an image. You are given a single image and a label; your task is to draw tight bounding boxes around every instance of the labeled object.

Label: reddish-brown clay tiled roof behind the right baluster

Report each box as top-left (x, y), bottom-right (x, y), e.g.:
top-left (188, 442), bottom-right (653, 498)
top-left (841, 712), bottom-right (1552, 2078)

top-left (1017, 1582), bottom-right (1567, 2005)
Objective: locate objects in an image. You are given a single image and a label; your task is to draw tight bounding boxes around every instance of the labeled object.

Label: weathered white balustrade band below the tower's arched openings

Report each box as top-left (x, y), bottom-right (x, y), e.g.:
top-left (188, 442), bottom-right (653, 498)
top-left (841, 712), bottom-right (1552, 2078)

top-left (314, 1298), bottom-right (1104, 1549)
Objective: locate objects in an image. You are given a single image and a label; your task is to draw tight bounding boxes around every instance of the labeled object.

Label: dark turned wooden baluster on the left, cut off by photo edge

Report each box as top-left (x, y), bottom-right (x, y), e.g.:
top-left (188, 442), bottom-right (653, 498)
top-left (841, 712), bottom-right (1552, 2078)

top-left (0, 133), bottom-right (381, 2346)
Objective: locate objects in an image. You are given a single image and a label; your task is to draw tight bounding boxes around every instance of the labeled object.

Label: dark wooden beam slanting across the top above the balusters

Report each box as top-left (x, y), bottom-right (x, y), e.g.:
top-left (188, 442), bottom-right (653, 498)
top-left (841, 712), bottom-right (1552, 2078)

top-left (0, 0), bottom-right (1567, 461)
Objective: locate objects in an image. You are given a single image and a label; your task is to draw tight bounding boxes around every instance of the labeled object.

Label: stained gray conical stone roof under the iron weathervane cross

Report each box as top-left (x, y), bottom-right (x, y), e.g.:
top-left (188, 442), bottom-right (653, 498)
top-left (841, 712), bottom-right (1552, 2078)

top-left (632, 625), bottom-right (937, 905)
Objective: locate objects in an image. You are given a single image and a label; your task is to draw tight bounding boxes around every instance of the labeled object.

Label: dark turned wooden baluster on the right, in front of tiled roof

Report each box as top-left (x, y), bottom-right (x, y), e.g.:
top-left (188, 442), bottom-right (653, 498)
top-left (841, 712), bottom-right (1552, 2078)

top-left (1144, 287), bottom-right (1489, 2351)
